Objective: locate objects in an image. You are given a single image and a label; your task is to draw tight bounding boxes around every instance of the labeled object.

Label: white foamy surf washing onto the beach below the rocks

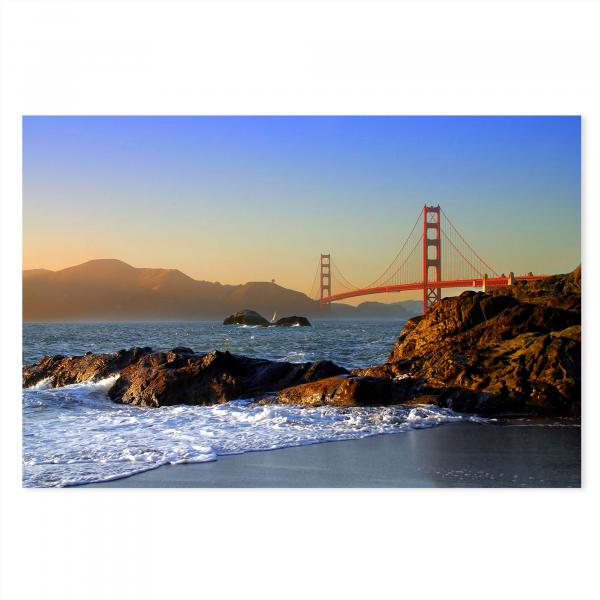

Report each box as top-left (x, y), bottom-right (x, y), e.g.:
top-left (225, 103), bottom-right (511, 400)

top-left (23, 377), bottom-right (484, 487)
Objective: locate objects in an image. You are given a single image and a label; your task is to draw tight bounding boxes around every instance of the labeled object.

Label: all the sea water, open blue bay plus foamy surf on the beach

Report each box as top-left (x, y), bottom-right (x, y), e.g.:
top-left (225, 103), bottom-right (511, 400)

top-left (23, 321), bottom-right (483, 487)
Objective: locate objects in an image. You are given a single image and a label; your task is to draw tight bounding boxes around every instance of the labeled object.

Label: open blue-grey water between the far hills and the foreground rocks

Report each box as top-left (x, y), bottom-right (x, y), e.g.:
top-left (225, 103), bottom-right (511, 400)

top-left (23, 320), bottom-right (404, 368)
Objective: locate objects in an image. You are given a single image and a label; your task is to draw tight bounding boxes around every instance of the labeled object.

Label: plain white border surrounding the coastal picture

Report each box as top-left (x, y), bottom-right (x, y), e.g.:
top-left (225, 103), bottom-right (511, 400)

top-left (0, 0), bottom-right (600, 600)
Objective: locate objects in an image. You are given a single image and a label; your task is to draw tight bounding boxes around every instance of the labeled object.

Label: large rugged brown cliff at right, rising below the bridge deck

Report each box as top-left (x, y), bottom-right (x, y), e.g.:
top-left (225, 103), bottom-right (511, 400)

top-left (376, 268), bottom-right (581, 414)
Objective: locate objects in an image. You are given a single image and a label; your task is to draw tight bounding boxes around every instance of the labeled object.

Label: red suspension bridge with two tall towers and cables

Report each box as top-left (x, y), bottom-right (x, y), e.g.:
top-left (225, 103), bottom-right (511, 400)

top-left (310, 205), bottom-right (549, 313)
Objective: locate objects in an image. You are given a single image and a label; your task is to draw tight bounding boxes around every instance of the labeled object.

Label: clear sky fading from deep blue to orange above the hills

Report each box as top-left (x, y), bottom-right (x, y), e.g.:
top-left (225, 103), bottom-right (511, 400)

top-left (23, 116), bottom-right (581, 301)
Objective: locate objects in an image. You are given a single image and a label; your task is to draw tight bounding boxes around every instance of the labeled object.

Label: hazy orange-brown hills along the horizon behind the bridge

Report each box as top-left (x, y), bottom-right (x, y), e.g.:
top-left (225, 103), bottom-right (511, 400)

top-left (23, 259), bottom-right (419, 321)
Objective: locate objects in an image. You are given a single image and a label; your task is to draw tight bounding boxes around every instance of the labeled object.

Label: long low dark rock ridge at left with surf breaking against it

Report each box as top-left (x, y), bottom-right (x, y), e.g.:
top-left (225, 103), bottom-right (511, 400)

top-left (23, 348), bottom-right (347, 407)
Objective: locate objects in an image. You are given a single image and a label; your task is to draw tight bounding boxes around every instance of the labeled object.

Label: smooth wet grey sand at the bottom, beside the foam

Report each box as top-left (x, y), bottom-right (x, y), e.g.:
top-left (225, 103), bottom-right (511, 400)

top-left (86, 422), bottom-right (581, 488)
